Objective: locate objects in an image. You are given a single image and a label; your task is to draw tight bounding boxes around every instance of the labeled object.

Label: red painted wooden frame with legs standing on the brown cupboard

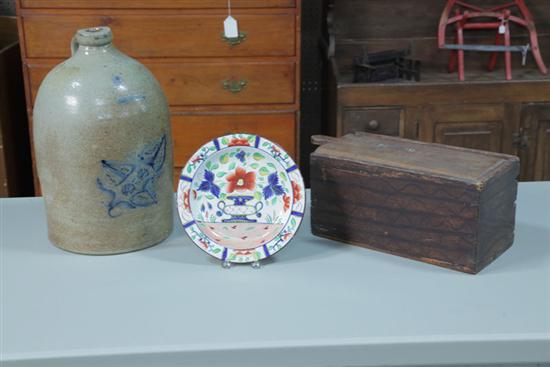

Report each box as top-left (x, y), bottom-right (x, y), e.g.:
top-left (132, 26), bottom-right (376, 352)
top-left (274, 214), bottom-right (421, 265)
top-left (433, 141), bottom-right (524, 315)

top-left (438, 0), bottom-right (548, 81)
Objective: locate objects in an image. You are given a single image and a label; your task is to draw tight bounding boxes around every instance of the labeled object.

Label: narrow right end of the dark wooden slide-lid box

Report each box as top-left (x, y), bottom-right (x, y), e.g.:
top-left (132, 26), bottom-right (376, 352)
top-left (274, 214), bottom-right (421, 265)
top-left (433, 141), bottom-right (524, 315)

top-left (476, 160), bottom-right (519, 272)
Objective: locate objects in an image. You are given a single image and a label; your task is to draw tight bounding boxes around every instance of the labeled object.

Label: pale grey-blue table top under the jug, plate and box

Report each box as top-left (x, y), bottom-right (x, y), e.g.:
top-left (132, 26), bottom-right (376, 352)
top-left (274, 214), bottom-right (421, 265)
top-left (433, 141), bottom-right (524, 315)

top-left (0, 183), bottom-right (550, 367)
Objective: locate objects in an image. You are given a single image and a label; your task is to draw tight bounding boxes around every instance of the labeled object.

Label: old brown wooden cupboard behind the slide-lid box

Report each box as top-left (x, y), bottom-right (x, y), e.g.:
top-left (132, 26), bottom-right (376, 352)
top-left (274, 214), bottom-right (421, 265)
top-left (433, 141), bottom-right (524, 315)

top-left (328, 0), bottom-right (550, 181)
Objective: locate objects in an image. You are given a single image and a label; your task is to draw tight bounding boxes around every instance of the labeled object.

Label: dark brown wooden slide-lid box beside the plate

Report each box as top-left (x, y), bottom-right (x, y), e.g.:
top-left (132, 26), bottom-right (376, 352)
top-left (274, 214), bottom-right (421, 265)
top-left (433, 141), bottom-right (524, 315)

top-left (311, 133), bottom-right (519, 274)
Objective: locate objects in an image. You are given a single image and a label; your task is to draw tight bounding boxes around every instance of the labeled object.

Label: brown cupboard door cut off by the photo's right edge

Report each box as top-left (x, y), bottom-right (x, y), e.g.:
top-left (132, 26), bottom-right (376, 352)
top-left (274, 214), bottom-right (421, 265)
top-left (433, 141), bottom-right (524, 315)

top-left (521, 104), bottom-right (550, 181)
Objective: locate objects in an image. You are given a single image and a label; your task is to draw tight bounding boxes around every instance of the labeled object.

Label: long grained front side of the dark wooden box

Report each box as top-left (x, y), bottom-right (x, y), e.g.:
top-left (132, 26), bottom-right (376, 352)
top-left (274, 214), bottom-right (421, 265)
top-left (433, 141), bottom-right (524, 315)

top-left (311, 155), bottom-right (479, 272)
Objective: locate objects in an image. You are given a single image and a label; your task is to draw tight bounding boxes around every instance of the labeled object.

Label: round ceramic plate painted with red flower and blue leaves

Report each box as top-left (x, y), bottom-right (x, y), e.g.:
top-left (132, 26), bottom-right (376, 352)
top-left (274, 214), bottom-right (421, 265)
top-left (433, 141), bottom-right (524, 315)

top-left (178, 134), bottom-right (305, 263)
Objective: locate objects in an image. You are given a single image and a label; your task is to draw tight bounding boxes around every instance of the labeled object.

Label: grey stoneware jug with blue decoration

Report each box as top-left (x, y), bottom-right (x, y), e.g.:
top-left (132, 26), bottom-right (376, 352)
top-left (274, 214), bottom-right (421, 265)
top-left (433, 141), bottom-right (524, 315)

top-left (33, 27), bottom-right (173, 255)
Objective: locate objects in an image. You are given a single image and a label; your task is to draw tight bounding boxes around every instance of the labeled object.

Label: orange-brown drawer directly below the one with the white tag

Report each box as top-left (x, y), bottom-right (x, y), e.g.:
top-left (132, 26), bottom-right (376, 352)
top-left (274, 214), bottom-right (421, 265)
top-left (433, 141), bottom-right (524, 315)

top-left (28, 60), bottom-right (296, 106)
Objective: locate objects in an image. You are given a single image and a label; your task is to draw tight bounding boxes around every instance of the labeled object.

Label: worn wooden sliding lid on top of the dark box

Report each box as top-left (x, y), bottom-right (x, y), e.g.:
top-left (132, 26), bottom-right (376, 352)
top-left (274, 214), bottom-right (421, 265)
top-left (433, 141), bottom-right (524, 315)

top-left (313, 133), bottom-right (519, 184)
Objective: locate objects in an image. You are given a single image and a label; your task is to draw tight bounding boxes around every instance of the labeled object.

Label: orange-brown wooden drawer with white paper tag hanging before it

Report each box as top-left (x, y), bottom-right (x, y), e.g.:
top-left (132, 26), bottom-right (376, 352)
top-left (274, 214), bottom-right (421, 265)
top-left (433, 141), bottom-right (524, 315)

top-left (22, 10), bottom-right (296, 58)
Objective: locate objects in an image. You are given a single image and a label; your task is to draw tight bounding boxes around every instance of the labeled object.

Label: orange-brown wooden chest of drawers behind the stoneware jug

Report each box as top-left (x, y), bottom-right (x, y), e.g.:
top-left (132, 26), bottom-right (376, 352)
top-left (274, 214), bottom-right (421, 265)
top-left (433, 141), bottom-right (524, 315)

top-left (17, 0), bottom-right (301, 193)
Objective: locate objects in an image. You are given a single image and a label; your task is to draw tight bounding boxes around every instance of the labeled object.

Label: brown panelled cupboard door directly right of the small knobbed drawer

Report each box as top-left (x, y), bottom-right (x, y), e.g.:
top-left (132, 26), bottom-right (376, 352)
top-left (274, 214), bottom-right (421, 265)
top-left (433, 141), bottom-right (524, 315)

top-left (419, 104), bottom-right (519, 154)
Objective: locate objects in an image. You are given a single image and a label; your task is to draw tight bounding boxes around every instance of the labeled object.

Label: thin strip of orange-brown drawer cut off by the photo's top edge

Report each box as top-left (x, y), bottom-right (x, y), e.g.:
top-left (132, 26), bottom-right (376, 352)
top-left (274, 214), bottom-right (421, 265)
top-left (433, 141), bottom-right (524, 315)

top-left (21, 0), bottom-right (296, 9)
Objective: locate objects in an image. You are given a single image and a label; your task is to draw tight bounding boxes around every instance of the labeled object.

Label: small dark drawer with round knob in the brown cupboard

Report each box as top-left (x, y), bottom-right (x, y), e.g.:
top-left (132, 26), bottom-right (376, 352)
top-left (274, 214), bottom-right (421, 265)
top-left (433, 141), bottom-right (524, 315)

top-left (342, 107), bottom-right (404, 136)
